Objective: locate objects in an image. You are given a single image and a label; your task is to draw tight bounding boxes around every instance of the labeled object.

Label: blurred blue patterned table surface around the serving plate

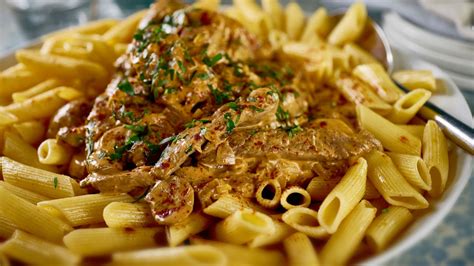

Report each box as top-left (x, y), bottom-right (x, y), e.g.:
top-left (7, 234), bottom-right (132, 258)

top-left (0, 0), bottom-right (474, 266)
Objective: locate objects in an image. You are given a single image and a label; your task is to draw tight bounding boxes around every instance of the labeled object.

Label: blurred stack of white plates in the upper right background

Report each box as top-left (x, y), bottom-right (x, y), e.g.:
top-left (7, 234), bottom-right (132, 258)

top-left (382, 12), bottom-right (474, 91)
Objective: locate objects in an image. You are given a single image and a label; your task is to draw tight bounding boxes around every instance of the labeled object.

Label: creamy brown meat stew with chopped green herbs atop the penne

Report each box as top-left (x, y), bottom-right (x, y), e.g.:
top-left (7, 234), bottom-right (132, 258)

top-left (51, 1), bottom-right (380, 224)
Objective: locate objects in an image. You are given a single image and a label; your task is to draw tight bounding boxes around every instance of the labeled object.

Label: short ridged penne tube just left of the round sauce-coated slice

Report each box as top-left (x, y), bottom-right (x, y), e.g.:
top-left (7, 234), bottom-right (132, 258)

top-left (103, 202), bottom-right (155, 228)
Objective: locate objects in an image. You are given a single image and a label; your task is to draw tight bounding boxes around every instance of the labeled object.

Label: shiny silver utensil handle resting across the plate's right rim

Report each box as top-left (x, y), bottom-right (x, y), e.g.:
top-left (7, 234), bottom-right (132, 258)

top-left (394, 80), bottom-right (474, 155)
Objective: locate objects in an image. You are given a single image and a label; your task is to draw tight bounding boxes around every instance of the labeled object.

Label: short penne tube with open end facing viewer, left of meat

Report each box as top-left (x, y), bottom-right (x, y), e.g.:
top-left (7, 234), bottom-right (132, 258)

top-left (38, 139), bottom-right (72, 165)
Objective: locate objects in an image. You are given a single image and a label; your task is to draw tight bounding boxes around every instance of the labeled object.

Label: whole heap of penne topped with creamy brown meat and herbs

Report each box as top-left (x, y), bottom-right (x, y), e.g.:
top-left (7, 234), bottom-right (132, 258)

top-left (0, 0), bottom-right (449, 265)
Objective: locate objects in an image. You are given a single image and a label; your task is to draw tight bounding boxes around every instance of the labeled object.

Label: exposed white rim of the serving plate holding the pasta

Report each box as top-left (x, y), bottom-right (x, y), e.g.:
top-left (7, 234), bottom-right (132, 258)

top-left (0, 33), bottom-right (473, 265)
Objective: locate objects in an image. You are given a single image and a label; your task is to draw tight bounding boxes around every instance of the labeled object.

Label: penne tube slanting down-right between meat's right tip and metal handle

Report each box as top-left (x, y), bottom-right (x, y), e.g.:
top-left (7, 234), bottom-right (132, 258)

top-left (356, 104), bottom-right (421, 156)
